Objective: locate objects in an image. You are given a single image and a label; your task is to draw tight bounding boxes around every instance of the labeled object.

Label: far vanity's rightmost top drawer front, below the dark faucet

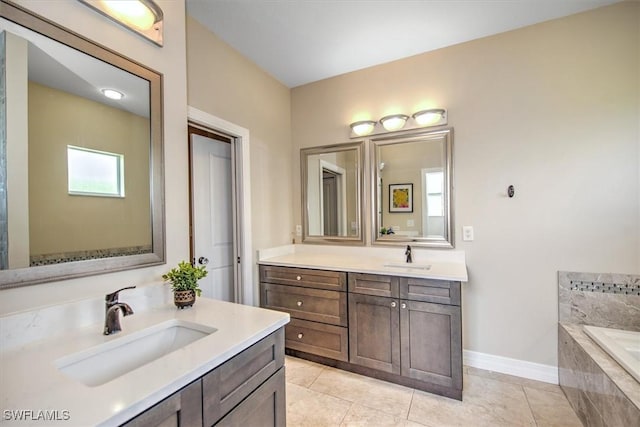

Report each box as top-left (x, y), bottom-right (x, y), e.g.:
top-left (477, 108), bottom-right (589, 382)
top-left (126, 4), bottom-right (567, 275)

top-left (400, 277), bottom-right (460, 305)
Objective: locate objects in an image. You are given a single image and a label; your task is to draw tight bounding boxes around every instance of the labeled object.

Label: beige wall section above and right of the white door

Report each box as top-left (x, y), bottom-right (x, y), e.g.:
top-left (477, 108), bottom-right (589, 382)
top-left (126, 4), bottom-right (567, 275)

top-left (185, 17), bottom-right (292, 296)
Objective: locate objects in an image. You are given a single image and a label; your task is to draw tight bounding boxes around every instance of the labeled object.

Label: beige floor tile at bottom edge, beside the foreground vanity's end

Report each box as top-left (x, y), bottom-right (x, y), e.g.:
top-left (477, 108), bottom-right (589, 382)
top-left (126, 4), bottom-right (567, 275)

top-left (286, 383), bottom-right (351, 427)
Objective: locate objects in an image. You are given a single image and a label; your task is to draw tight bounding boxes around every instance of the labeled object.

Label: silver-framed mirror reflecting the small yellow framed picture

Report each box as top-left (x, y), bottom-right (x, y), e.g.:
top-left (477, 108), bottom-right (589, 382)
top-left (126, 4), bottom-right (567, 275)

top-left (370, 128), bottom-right (454, 248)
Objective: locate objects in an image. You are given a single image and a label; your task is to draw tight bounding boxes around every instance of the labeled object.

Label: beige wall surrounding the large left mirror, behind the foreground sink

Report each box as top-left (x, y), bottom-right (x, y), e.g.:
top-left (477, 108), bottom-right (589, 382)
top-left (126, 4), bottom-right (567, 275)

top-left (0, 0), bottom-right (189, 315)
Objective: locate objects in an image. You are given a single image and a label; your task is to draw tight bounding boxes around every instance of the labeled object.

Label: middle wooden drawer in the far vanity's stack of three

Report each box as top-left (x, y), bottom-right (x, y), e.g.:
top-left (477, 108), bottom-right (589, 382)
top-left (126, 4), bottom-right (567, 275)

top-left (260, 283), bottom-right (347, 326)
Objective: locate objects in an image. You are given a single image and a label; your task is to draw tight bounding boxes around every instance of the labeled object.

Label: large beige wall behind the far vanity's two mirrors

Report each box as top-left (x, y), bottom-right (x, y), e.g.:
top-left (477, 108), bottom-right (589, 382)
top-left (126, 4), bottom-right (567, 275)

top-left (291, 2), bottom-right (640, 365)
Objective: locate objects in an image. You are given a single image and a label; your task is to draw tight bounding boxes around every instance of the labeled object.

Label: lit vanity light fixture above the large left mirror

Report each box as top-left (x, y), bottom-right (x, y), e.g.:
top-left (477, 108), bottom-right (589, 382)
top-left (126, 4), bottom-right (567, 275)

top-left (78, 0), bottom-right (164, 46)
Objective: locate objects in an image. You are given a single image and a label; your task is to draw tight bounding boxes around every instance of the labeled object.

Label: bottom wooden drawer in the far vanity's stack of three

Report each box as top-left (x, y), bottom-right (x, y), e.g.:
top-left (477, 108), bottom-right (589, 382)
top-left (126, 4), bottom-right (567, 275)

top-left (285, 319), bottom-right (349, 362)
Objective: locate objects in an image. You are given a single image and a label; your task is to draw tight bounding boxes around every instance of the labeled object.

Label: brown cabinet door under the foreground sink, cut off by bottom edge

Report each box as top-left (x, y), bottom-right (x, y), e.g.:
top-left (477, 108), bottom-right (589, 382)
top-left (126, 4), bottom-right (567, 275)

top-left (123, 380), bottom-right (202, 427)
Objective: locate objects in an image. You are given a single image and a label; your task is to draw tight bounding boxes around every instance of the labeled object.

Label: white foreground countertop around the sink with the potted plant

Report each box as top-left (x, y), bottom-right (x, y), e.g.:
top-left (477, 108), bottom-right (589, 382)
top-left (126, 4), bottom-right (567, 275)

top-left (0, 298), bottom-right (289, 426)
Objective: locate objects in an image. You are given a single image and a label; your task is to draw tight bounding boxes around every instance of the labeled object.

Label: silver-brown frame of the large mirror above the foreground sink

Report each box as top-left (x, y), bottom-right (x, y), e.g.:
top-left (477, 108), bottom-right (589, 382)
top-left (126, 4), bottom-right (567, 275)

top-left (0, 0), bottom-right (166, 289)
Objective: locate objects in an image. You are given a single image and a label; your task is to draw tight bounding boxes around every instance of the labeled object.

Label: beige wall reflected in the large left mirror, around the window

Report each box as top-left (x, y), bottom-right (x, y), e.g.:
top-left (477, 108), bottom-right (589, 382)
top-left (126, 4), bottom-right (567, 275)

top-left (28, 82), bottom-right (151, 255)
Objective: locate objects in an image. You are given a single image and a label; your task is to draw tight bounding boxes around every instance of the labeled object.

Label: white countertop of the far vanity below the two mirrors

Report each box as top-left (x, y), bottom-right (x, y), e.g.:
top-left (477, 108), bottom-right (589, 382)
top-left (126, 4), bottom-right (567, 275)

top-left (258, 245), bottom-right (468, 282)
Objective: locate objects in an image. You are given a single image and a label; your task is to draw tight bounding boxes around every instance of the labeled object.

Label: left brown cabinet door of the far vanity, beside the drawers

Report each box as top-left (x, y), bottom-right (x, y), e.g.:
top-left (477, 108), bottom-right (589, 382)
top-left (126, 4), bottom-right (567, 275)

top-left (349, 294), bottom-right (400, 374)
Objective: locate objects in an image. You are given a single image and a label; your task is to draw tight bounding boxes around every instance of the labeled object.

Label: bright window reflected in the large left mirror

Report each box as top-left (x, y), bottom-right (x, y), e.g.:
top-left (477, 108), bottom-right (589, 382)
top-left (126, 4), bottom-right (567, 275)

top-left (67, 145), bottom-right (124, 197)
